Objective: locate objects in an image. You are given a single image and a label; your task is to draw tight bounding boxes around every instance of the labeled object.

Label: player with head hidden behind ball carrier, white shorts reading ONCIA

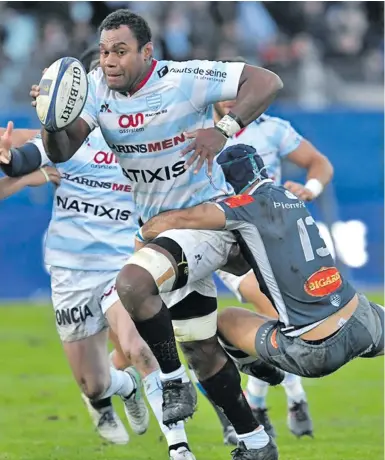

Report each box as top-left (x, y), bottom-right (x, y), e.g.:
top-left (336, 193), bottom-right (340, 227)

top-left (0, 50), bottom-right (195, 460)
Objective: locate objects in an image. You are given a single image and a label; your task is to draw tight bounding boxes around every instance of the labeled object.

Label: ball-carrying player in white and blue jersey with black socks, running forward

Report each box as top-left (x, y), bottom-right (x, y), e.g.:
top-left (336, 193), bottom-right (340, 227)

top-left (31, 10), bottom-right (282, 460)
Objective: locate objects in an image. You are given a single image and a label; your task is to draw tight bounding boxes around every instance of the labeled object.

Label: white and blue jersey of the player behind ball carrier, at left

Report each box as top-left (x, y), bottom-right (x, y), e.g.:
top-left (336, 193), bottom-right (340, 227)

top-left (31, 129), bottom-right (138, 271)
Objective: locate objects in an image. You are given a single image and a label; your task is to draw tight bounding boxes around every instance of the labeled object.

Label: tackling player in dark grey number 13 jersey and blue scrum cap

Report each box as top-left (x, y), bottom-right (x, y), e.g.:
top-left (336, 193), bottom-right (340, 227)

top-left (134, 145), bottom-right (384, 456)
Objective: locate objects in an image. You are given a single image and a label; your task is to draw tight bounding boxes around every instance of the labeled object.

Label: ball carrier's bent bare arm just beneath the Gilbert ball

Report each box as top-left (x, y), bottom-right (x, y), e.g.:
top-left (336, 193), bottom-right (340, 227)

top-left (41, 118), bottom-right (91, 163)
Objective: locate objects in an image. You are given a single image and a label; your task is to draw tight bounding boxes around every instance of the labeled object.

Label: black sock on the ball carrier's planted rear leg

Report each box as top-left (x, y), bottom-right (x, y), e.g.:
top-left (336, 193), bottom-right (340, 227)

top-left (200, 360), bottom-right (258, 434)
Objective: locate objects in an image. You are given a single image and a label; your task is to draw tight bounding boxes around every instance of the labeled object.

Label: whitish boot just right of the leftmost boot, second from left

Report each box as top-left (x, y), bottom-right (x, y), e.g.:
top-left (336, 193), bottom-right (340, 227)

top-left (121, 367), bottom-right (150, 434)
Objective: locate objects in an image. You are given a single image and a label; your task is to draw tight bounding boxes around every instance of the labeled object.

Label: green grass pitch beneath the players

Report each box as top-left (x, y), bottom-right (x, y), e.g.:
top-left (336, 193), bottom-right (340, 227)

top-left (0, 294), bottom-right (384, 460)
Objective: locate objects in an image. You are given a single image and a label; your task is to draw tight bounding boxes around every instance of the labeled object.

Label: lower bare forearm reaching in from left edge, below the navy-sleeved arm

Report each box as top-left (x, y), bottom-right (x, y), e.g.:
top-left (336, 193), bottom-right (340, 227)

top-left (0, 166), bottom-right (60, 200)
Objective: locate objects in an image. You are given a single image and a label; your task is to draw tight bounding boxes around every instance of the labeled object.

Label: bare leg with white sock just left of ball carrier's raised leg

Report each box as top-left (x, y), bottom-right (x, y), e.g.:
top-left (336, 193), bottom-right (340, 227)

top-left (106, 301), bottom-right (195, 460)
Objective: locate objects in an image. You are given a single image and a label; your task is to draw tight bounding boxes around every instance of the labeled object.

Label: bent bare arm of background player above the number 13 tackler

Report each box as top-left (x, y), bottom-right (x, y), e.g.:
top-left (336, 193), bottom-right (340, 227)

top-left (287, 139), bottom-right (333, 186)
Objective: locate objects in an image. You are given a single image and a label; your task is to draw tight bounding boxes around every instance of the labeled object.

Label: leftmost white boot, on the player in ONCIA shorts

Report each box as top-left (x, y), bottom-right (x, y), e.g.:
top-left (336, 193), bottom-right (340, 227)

top-left (82, 393), bottom-right (130, 444)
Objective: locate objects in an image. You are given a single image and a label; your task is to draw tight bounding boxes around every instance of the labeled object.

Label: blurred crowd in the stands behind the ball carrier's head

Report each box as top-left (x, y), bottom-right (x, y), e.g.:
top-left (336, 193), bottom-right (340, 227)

top-left (0, 1), bottom-right (384, 108)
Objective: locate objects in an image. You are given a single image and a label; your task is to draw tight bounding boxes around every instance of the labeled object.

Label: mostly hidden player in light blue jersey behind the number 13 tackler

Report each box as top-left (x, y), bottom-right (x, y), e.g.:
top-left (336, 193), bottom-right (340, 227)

top-left (202, 84), bottom-right (333, 444)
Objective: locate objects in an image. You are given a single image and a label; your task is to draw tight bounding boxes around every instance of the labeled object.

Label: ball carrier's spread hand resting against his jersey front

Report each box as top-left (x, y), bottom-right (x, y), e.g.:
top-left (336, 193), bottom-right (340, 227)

top-left (181, 128), bottom-right (227, 176)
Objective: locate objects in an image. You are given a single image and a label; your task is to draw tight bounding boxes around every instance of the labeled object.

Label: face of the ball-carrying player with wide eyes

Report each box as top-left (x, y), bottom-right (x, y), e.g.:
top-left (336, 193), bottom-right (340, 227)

top-left (100, 26), bottom-right (152, 91)
